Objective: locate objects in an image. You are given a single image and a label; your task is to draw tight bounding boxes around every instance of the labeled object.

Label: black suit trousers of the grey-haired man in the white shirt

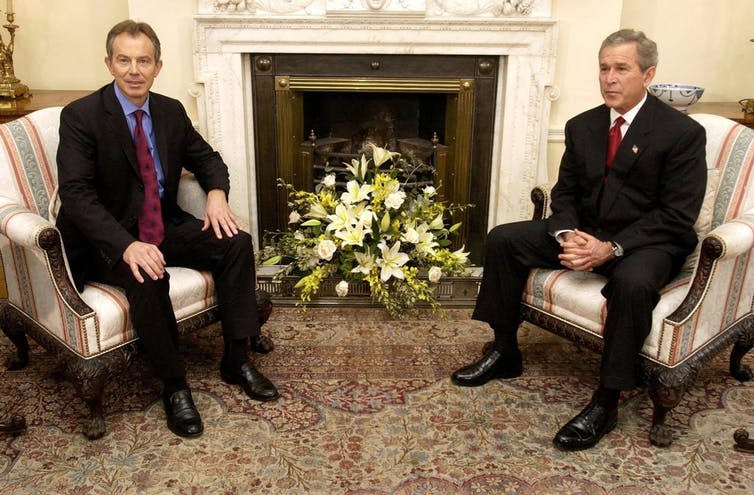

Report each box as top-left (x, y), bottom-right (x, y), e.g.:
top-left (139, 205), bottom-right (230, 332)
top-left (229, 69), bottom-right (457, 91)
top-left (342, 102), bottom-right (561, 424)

top-left (472, 220), bottom-right (683, 390)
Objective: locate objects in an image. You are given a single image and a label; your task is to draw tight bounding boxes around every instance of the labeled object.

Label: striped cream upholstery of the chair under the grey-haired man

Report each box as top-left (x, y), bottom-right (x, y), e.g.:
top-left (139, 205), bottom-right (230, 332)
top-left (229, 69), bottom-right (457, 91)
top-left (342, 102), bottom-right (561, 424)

top-left (523, 114), bottom-right (754, 367)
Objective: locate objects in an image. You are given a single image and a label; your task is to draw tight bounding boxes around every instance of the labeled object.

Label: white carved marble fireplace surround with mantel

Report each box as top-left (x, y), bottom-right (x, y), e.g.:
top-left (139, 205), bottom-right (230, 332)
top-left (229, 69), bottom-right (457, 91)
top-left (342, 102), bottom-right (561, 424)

top-left (194, 0), bottom-right (558, 245)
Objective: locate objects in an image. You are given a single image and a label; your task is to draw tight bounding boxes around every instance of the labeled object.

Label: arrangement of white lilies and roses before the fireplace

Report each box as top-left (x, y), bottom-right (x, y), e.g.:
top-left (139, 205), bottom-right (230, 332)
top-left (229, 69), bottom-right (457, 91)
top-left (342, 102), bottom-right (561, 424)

top-left (258, 145), bottom-right (470, 316)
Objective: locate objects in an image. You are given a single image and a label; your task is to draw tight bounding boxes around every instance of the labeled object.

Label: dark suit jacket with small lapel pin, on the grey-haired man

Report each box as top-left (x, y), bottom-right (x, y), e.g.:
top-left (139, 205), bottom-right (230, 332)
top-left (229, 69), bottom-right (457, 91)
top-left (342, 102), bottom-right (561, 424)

top-left (548, 95), bottom-right (707, 257)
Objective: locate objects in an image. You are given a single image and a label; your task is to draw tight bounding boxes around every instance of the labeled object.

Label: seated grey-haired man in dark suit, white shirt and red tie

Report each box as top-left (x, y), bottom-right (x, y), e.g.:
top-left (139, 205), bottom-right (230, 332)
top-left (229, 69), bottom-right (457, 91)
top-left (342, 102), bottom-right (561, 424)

top-left (452, 30), bottom-right (706, 450)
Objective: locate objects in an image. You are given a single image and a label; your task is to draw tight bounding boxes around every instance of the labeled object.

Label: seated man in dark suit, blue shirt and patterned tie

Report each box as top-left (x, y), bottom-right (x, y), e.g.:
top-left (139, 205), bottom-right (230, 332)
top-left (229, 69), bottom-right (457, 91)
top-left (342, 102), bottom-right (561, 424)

top-left (57, 20), bottom-right (278, 437)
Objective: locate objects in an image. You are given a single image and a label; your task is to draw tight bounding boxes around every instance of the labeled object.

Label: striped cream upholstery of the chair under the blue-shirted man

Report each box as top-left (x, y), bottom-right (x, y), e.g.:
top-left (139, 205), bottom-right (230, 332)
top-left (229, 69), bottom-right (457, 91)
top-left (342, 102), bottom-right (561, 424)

top-left (0, 107), bottom-right (216, 358)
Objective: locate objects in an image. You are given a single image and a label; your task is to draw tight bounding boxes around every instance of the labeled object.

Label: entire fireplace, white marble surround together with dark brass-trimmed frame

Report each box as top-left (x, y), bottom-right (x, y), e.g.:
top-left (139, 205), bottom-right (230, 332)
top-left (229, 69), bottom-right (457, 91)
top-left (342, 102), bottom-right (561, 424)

top-left (192, 0), bottom-right (558, 268)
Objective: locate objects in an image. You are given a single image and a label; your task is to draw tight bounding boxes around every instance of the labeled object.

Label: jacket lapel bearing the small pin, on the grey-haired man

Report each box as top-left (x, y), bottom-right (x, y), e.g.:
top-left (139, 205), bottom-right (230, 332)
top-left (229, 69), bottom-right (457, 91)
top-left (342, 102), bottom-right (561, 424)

top-left (600, 96), bottom-right (655, 216)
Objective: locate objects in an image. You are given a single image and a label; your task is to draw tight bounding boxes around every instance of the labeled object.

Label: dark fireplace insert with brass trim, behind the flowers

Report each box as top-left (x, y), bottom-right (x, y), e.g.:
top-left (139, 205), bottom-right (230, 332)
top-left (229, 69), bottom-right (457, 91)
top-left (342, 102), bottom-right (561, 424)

top-left (251, 54), bottom-right (498, 261)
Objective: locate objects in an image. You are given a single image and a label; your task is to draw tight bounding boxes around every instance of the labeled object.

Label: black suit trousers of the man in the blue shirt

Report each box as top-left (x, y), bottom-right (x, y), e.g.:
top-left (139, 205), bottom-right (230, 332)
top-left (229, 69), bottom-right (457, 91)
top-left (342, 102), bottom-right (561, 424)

top-left (86, 216), bottom-right (259, 380)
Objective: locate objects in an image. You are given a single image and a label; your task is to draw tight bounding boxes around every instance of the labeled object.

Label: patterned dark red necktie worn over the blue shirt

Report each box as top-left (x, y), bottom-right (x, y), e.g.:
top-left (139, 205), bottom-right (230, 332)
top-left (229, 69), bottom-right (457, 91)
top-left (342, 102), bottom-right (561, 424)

top-left (134, 110), bottom-right (165, 246)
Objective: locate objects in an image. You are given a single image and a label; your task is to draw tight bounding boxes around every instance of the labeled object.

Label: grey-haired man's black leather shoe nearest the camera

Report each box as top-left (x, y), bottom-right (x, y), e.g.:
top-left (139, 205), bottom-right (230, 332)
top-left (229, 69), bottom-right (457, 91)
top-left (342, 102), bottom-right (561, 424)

top-left (552, 398), bottom-right (618, 451)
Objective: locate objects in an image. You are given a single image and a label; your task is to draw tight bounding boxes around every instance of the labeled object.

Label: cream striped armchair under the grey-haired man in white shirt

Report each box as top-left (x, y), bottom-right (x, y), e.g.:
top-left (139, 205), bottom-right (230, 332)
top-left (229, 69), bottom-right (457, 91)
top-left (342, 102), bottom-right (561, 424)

top-left (522, 114), bottom-right (754, 446)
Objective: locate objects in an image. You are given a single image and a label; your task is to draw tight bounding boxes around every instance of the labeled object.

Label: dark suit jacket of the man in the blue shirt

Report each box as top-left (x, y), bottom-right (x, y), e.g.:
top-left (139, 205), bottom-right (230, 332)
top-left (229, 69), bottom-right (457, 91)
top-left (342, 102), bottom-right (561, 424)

top-left (57, 83), bottom-right (230, 290)
